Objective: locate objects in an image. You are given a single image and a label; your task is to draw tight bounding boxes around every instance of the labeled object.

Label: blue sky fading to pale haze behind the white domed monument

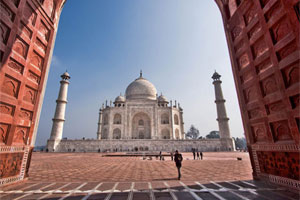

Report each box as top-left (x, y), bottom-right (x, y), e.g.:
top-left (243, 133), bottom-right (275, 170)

top-left (36, 0), bottom-right (244, 145)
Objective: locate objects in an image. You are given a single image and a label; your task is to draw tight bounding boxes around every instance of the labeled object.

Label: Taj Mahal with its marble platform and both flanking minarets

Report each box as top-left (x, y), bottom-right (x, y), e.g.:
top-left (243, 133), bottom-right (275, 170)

top-left (47, 71), bottom-right (235, 152)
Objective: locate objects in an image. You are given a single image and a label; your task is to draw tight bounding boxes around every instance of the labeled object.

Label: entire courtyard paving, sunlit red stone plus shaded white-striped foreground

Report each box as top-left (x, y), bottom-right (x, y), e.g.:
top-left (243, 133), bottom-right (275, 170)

top-left (0, 152), bottom-right (299, 200)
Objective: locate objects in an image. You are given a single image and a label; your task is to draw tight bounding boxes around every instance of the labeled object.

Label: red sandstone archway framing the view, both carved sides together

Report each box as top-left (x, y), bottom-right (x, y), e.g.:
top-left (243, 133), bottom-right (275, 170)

top-left (0, 0), bottom-right (300, 189)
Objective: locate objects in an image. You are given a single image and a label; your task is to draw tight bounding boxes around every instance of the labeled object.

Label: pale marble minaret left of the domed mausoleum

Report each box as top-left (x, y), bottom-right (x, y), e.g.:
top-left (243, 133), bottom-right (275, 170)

top-left (48, 72), bottom-right (71, 151)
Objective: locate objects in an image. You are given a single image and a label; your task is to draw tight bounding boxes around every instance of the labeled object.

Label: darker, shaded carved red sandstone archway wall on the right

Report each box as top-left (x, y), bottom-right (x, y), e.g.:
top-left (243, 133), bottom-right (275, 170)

top-left (215, 0), bottom-right (300, 189)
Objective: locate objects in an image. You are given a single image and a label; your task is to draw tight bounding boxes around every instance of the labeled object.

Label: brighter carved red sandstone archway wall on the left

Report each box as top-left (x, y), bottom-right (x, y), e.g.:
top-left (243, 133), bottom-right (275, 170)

top-left (0, 0), bottom-right (64, 185)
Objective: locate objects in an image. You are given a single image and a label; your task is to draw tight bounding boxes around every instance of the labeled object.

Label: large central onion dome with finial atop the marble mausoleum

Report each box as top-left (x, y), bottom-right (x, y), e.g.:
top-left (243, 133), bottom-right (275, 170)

top-left (126, 72), bottom-right (157, 100)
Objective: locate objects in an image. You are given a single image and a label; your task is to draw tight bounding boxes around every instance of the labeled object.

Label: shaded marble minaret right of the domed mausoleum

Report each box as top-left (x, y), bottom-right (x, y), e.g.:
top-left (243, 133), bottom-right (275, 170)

top-left (211, 71), bottom-right (234, 150)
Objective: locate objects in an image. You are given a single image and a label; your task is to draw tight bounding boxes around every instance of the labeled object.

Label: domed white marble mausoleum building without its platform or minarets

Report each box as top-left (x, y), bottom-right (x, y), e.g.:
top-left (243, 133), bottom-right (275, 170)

top-left (97, 72), bottom-right (185, 140)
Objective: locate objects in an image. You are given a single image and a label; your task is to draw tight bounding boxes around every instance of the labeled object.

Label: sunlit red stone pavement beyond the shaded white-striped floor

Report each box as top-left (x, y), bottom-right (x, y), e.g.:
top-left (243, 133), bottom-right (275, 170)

top-left (29, 152), bottom-right (252, 182)
